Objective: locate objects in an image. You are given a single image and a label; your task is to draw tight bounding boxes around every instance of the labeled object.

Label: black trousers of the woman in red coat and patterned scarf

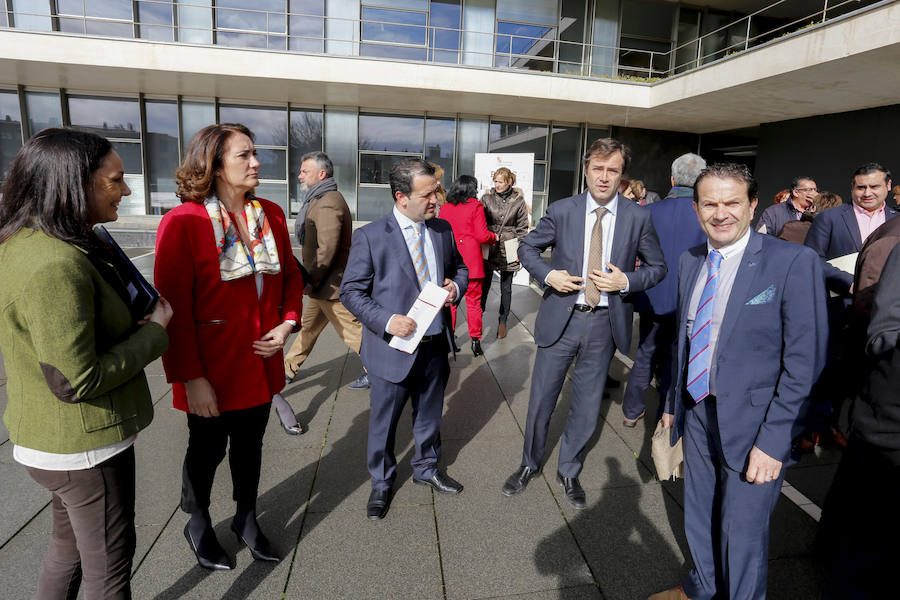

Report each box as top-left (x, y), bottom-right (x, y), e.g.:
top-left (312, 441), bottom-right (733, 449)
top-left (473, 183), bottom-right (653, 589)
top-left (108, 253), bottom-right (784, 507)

top-left (181, 402), bottom-right (271, 513)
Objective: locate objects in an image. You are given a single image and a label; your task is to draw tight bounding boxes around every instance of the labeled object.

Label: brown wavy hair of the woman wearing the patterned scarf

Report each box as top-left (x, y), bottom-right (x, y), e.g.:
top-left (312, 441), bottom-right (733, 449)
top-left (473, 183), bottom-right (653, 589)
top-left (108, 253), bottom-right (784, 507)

top-left (175, 123), bottom-right (256, 203)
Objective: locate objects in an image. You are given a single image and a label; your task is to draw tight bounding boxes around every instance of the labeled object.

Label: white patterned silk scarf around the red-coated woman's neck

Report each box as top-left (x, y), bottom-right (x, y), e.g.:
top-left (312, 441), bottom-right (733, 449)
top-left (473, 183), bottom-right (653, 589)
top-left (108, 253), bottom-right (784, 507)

top-left (203, 196), bottom-right (281, 281)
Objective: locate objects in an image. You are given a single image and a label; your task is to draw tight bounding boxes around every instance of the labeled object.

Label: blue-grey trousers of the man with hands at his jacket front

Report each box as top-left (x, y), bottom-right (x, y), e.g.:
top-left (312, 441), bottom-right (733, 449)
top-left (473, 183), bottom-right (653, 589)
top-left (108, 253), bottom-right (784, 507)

top-left (522, 308), bottom-right (615, 477)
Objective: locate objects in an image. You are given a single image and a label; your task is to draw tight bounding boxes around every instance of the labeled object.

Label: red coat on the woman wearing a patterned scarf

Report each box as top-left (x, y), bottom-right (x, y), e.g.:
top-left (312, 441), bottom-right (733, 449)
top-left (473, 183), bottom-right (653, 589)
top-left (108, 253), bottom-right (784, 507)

top-left (154, 198), bottom-right (303, 412)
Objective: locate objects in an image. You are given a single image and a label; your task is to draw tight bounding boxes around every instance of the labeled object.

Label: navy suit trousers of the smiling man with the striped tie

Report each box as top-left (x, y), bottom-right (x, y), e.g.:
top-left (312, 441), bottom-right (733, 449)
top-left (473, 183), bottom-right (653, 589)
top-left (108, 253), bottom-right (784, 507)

top-left (684, 396), bottom-right (784, 600)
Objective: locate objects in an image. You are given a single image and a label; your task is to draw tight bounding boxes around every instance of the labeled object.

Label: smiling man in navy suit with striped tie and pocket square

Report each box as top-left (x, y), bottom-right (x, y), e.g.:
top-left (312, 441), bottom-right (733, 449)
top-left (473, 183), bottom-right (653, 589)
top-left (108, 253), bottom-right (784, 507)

top-left (650, 164), bottom-right (827, 600)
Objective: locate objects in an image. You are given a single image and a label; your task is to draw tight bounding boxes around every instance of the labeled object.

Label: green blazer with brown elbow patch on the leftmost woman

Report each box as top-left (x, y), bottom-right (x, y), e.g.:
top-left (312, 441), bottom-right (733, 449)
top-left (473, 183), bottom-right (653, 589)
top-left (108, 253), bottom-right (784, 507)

top-left (0, 229), bottom-right (169, 454)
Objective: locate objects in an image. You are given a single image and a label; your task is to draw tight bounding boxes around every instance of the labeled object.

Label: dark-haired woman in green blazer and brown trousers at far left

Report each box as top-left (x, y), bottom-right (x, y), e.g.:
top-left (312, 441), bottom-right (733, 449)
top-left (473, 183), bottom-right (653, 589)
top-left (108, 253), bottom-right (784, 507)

top-left (0, 129), bottom-right (172, 600)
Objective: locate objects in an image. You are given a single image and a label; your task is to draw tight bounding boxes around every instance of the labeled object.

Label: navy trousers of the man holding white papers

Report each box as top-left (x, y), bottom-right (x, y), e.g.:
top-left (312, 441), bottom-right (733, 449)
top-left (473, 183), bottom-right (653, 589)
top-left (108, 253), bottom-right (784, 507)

top-left (366, 333), bottom-right (450, 490)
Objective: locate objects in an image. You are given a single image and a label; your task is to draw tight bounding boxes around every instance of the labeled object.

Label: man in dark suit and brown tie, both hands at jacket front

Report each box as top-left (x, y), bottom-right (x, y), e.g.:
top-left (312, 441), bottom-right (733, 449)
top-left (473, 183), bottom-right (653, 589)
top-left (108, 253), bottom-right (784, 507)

top-left (501, 138), bottom-right (666, 508)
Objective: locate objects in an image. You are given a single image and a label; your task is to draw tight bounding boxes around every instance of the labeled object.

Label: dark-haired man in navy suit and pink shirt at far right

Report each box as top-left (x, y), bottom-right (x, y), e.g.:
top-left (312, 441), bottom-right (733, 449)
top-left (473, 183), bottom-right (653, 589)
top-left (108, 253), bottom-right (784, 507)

top-left (804, 163), bottom-right (897, 448)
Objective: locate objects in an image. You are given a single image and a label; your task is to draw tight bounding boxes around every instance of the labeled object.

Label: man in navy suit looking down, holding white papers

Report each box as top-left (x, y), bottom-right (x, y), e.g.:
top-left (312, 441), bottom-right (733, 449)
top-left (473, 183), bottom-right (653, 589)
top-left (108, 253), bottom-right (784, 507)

top-left (340, 159), bottom-right (469, 520)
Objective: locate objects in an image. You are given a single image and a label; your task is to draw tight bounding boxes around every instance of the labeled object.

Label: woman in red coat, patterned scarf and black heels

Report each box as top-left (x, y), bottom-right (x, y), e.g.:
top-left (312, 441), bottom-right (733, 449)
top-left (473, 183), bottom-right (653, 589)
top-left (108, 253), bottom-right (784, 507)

top-left (154, 124), bottom-right (303, 569)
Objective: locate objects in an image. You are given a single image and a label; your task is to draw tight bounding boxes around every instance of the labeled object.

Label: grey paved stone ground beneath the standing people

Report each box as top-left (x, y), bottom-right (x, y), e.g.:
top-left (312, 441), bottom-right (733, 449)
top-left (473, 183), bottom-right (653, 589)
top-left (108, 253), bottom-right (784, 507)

top-left (0, 250), bottom-right (839, 600)
